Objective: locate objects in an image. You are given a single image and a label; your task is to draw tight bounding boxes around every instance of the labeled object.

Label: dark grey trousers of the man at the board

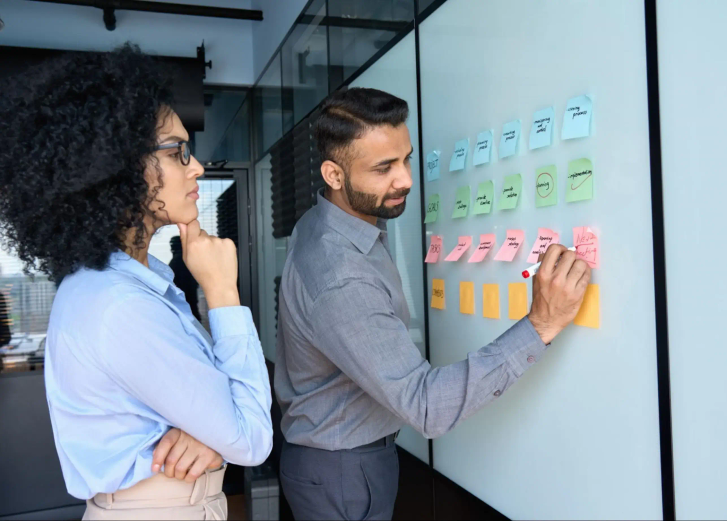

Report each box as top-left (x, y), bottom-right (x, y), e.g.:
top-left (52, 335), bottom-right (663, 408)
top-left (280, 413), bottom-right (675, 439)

top-left (280, 441), bottom-right (399, 521)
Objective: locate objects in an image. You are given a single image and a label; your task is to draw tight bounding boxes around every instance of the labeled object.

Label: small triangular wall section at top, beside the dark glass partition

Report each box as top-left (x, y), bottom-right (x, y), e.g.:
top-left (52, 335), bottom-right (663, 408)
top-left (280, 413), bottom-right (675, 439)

top-left (250, 0), bottom-right (308, 80)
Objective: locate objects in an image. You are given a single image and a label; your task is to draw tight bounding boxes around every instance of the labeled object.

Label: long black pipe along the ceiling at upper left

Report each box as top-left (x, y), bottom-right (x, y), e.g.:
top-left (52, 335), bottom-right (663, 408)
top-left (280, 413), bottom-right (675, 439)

top-left (31, 0), bottom-right (263, 24)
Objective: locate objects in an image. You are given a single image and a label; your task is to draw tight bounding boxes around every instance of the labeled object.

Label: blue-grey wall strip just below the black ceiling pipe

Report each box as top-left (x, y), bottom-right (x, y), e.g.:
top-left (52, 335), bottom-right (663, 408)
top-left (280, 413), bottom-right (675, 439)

top-left (0, 0), bottom-right (256, 85)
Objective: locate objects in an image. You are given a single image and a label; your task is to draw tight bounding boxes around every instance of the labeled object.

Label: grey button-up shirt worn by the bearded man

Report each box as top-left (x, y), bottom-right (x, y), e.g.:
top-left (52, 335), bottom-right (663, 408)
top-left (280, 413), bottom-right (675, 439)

top-left (275, 194), bottom-right (545, 450)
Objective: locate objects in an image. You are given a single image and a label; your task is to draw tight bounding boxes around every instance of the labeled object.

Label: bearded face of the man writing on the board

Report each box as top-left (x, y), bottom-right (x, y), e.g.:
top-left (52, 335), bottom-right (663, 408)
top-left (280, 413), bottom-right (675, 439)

top-left (343, 124), bottom-right (413, 219)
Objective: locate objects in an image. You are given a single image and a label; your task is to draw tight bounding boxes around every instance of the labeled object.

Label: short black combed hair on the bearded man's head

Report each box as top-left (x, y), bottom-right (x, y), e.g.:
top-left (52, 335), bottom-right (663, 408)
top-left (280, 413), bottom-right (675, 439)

top-left (313, 88), bottom-right (409, 168)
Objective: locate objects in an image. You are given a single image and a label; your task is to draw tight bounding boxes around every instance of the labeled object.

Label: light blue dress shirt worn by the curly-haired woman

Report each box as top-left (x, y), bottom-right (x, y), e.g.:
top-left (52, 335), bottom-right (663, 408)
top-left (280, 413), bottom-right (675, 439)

top-left (45, 252), bottom-right (273, 499)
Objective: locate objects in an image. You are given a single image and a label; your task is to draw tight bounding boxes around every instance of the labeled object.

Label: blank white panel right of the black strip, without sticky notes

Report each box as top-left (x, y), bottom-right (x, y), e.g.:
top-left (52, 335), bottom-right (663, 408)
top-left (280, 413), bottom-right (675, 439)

top-left (657, 0), bottom-right (727, 519)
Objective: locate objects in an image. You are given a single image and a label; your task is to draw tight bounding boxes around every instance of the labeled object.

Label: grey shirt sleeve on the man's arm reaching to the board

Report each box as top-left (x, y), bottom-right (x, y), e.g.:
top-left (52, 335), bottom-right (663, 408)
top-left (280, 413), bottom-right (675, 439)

top-left (309, 279), bottom-right (546, 438)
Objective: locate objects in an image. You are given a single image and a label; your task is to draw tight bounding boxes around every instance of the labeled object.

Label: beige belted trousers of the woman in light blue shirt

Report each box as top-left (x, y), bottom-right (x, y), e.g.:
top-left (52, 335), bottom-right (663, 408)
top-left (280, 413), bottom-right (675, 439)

top-left (83, 467), bottom-right (227, 520)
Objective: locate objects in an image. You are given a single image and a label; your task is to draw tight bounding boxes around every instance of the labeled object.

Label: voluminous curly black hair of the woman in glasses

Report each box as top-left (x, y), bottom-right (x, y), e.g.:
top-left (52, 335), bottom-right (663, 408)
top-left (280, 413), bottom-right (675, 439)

top-left (0, 44), bottom-right (172, 280)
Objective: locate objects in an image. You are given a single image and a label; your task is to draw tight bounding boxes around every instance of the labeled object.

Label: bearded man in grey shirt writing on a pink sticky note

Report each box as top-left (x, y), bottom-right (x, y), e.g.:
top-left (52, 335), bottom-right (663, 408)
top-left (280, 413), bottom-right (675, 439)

top-left (275, 89), bottom-right (590, 519)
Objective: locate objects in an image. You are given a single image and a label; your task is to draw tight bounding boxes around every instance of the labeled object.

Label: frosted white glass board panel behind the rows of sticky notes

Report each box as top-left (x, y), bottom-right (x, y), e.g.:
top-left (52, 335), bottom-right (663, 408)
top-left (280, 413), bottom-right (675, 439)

top-left (420, 0), bottom-right (662, 519)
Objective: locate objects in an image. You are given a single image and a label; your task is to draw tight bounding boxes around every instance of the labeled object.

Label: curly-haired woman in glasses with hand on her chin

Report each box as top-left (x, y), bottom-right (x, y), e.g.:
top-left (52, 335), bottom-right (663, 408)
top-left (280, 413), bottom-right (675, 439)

top-left (0, 45), bottom-right (272, 519)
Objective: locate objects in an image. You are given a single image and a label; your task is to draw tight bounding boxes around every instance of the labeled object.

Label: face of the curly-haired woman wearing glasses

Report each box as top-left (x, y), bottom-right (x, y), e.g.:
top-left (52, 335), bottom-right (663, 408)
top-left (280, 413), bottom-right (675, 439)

top-left (146, 112), bottom-right (204, 224)
